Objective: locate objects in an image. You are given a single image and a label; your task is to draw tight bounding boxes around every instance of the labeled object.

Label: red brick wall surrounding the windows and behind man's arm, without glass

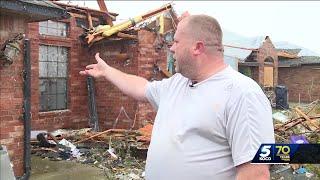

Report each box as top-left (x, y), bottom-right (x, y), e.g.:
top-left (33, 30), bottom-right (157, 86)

top-left (28, 18), bottom-right (166, 131)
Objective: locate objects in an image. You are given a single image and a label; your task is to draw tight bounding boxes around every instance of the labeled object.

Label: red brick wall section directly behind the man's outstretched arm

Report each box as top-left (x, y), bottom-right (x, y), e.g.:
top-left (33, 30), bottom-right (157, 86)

top-left (88, 30), bottom-right (166, 129)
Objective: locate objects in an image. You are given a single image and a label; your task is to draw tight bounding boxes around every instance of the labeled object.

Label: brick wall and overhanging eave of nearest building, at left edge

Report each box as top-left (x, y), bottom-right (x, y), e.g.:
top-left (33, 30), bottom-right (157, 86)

top-left (0, 0), bottom-right (67, 177)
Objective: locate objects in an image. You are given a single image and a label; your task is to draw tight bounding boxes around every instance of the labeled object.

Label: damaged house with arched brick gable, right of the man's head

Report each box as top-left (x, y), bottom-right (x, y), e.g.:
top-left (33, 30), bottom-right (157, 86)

top-left (224, 36), bottom-right (320, 102)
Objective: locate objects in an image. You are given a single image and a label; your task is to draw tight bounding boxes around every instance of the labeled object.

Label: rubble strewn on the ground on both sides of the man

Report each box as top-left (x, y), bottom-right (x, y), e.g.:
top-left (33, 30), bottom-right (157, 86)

top-left (32, 101), bottom-right (320, 179)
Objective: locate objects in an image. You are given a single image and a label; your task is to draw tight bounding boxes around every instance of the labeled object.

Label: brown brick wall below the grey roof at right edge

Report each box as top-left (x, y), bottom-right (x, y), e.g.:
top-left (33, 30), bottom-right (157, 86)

top-left (279, 65), bottom-right (320, 102)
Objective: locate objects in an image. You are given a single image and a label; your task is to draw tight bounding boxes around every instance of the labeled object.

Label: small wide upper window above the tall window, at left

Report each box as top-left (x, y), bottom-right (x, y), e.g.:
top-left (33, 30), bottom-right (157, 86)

top-left (39, 20), bottom-right (68, 37)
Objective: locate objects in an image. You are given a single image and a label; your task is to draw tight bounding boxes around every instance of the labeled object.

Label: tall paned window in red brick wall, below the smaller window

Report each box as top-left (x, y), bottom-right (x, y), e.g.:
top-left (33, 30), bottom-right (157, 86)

top-left (39, 45), bottom-right (68, 111)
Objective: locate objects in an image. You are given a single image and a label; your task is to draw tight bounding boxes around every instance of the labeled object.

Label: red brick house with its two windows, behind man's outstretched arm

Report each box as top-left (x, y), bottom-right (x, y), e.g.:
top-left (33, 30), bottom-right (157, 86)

top-left (28, 5), bottom-right (170, 131)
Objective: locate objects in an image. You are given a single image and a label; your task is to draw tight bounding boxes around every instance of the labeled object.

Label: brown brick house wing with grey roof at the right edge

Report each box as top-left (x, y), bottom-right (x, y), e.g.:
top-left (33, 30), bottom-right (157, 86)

top-left (279, 52), bottom-right (320, 102)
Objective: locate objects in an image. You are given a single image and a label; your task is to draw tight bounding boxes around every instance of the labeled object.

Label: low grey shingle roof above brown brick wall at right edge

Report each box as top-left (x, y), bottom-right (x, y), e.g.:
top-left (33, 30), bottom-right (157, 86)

top-left (279, 56), bottom-right (320, 67)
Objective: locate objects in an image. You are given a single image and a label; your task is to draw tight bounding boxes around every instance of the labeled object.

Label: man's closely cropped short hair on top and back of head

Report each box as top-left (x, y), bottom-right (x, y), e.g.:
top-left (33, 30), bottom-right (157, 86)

top-left (187, 15), bottom-right (223, 51)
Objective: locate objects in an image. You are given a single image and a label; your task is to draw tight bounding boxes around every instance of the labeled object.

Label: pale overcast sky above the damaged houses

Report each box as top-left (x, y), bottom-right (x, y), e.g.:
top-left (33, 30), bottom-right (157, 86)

top-left (62, 0), bottom-right (320, 54)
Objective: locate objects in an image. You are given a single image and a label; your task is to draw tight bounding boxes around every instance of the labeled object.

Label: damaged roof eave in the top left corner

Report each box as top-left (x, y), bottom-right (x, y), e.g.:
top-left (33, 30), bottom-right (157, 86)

top-left (0, 0), bottom-right (69, 22)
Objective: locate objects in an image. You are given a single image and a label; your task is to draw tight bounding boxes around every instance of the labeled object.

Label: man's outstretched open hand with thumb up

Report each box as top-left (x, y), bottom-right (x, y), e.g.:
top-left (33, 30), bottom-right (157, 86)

top-left (79, 53), bottom-right (109, 78)
